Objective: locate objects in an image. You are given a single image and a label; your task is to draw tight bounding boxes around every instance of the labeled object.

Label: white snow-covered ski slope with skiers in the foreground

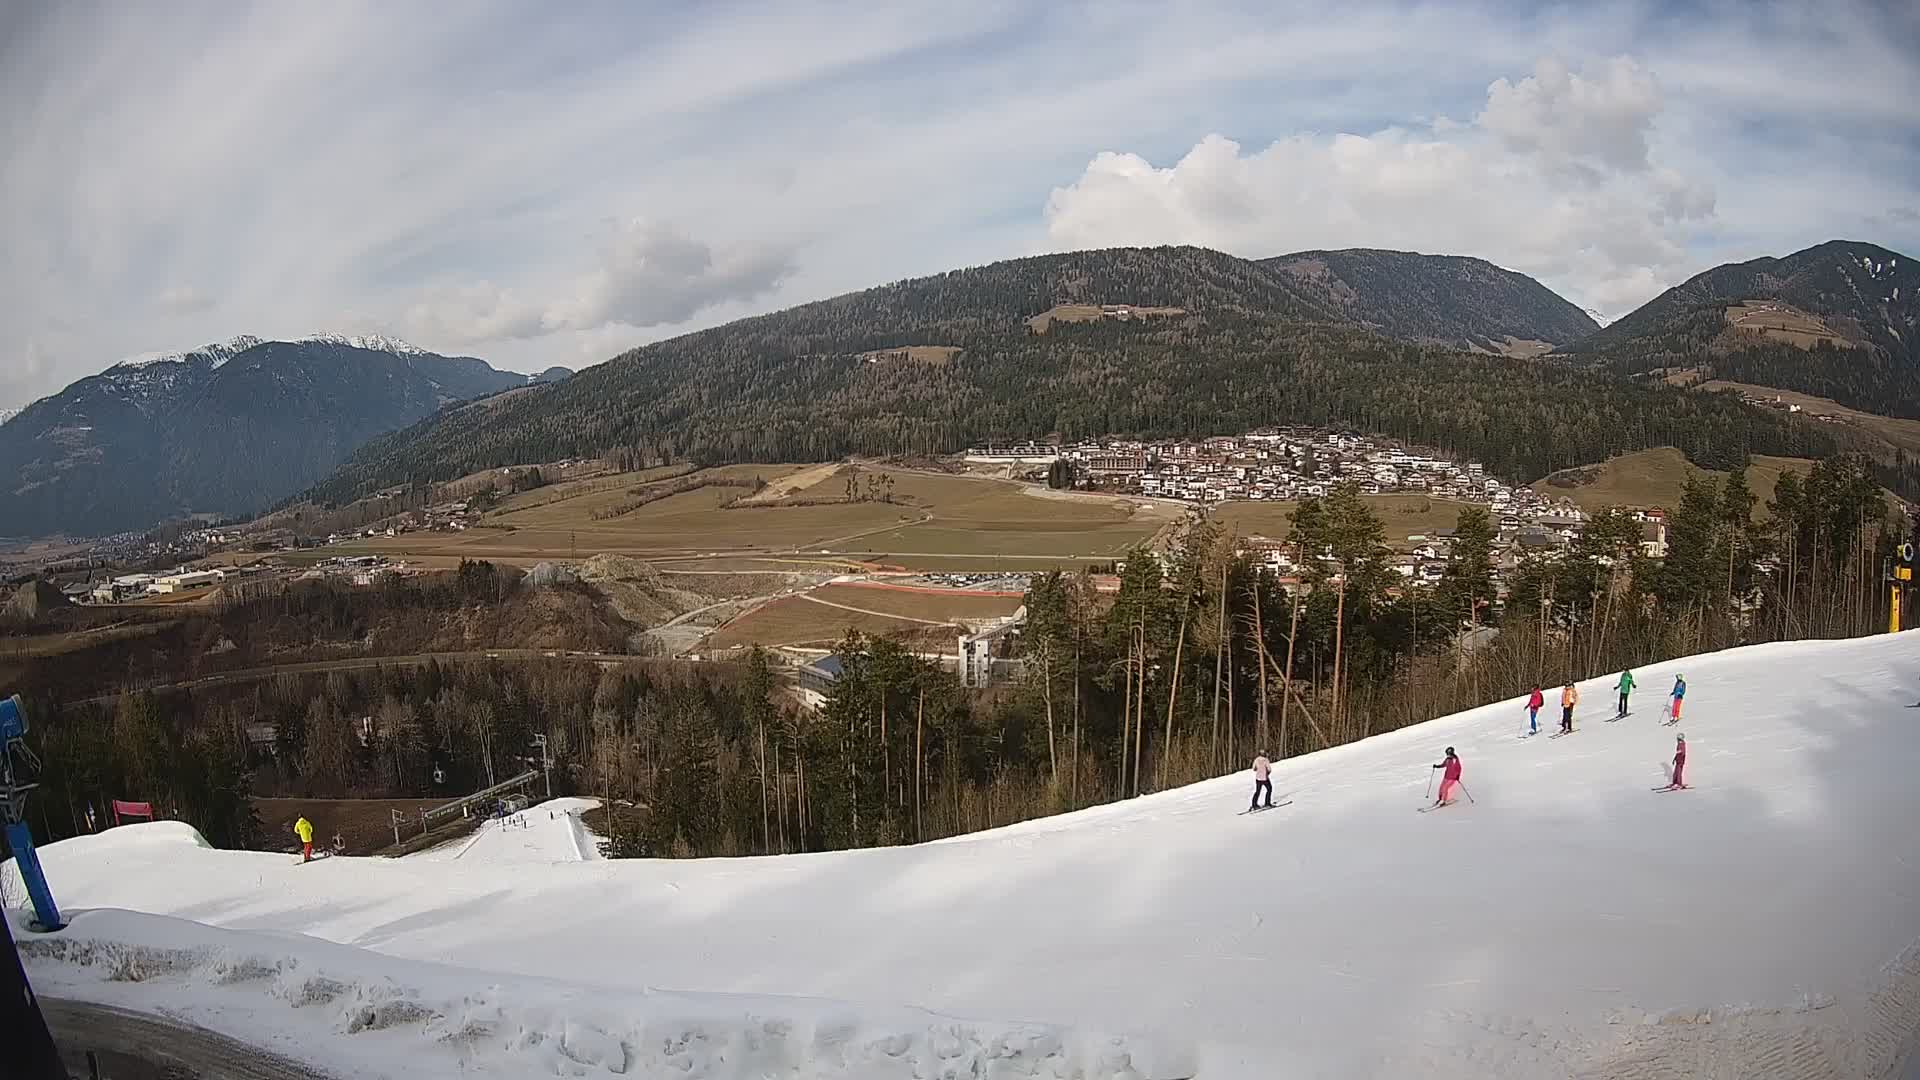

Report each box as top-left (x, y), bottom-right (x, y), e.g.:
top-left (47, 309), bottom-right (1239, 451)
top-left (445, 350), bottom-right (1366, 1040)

top-left (21, 632), bottom-right (1920, 1080)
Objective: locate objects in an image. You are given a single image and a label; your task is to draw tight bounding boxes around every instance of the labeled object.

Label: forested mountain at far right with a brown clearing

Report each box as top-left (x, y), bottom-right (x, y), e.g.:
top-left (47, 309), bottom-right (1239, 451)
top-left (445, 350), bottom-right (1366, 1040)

top-left (1561, 240), bottom-right (1920, 417)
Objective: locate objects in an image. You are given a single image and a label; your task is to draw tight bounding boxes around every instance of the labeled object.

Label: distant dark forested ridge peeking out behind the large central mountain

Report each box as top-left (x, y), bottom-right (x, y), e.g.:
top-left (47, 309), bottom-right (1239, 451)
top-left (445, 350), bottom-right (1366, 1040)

top-left (1261, 248), bottom-right (1599, 356)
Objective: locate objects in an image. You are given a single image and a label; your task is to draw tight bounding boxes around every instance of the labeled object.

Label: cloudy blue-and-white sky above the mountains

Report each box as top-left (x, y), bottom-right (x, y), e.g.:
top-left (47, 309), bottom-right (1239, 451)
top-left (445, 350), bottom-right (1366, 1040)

top-left (0, 0), bottom-right (1920, 407)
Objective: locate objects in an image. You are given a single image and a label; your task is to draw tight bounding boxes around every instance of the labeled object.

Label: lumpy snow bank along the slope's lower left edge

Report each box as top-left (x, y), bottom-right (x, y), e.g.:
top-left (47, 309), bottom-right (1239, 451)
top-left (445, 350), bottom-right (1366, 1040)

top-left (15, 911), bottom-right (1159, 1080)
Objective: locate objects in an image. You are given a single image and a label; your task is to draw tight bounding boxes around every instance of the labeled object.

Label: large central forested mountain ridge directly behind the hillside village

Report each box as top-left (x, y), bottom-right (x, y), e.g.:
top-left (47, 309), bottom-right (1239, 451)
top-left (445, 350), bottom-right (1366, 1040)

top-left (315, 248), bottom-right (1834, 502)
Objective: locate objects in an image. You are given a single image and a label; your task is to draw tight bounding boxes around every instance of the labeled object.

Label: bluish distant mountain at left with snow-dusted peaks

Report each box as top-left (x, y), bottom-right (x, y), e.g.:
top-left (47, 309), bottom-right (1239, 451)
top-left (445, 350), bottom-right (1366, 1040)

top-left (0, 334), bottom-right (568, 534)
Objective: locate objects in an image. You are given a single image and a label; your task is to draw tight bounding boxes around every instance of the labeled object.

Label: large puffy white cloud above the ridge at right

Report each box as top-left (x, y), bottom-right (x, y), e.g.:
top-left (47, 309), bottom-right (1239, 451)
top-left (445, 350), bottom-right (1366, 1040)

top-left (1046, 60), bottom-right (1715, 311)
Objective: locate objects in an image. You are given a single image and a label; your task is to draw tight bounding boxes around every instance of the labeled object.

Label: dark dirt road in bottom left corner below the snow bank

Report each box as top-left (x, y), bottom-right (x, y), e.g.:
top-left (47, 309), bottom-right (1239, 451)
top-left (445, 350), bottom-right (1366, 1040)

top-left (40, 997), bottom-right (326, 1080)
